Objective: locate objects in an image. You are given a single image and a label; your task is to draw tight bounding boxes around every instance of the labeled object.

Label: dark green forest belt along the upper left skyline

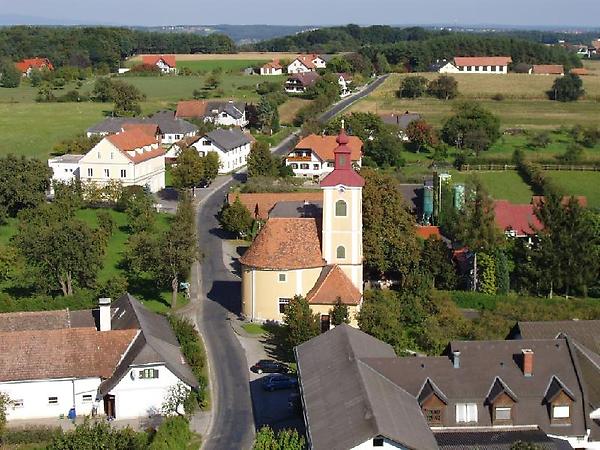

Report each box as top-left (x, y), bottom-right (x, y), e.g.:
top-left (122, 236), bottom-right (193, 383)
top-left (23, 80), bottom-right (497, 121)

top-left (0, 26), bottom-right (236, 71)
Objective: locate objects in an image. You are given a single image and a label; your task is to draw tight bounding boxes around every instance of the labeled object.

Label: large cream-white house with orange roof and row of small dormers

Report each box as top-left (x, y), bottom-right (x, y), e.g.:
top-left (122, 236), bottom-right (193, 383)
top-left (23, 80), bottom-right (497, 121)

top-left (79, 127), bottom-right (165, 192)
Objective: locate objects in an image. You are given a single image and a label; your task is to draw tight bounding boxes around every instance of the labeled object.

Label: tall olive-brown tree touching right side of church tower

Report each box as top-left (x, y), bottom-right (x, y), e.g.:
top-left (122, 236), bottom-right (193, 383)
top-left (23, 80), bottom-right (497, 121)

top-left (361, 169), bottom-right (420, 286)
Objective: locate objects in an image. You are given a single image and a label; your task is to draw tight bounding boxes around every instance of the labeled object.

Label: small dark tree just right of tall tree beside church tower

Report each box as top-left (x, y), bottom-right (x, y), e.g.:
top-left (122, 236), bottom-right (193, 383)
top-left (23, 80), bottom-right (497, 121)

top-left (421, 236), bottom-right (457, 290)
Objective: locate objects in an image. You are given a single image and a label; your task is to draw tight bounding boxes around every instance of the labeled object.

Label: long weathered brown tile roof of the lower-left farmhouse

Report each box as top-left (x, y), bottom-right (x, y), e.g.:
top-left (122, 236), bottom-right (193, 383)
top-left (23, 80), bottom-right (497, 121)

top-left (0, 328), bottom-right (138, 381)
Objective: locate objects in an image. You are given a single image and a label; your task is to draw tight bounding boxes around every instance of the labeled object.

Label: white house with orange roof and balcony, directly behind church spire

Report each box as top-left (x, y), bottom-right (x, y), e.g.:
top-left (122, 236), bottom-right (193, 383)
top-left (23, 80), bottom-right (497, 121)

top-left (285, 134), bottom-right (363, 180)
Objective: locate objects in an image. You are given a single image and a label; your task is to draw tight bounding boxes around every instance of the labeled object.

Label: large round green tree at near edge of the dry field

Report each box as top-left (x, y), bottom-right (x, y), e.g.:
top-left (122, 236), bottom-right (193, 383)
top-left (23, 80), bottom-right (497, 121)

top-left (441, 102), bottom-right (500, 150)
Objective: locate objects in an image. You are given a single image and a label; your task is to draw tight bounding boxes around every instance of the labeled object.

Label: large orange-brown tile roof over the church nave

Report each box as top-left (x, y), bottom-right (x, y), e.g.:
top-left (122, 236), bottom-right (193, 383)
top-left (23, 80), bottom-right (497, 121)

top-left (240, 218), bottom-right (325, 270)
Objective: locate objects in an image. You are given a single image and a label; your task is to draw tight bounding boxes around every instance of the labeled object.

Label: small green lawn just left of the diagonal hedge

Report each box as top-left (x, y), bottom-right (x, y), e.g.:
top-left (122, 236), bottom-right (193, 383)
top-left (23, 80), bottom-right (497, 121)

top-left (450, 170), bottom-right (533, 203)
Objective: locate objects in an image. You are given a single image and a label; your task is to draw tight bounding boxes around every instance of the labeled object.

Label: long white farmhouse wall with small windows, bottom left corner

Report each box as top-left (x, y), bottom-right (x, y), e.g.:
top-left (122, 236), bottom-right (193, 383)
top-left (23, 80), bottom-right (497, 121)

top-left (0, 378), bottom-right (100, 420)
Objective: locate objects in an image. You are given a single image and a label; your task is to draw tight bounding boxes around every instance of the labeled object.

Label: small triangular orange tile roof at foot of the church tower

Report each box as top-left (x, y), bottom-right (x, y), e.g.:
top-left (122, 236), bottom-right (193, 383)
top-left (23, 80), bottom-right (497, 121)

top-left (306, 264), bottom-right (362, 305)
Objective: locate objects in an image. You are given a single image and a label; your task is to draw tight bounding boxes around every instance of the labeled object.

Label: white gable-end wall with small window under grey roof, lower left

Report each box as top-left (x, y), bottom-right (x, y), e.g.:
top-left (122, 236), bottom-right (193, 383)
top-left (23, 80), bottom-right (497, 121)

top-left (109, 364), bottom-right (189, 420)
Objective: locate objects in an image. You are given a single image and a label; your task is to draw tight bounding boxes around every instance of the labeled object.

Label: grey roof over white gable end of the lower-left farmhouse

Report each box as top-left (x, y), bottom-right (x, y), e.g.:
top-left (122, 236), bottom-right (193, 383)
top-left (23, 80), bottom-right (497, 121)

top-left (100, 294), bottom-right (198, 394)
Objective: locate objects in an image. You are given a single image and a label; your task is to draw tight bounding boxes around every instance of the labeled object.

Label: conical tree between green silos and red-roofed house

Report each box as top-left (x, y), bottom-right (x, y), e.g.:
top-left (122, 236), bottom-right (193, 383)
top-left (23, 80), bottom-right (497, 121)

top-left (454, 178), bottom-right (503, 252)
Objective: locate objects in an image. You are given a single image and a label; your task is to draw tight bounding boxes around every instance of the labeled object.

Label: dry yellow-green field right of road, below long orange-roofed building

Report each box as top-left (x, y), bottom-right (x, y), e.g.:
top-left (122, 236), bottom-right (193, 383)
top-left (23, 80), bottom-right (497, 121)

top-left (351, 74), bottom-right (600, 130)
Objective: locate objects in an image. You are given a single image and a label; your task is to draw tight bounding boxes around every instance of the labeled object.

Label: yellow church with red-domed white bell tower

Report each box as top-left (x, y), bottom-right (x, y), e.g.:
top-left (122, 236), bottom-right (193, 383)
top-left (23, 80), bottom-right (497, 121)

top-left (240, 129), bottom-right (365, 331)
